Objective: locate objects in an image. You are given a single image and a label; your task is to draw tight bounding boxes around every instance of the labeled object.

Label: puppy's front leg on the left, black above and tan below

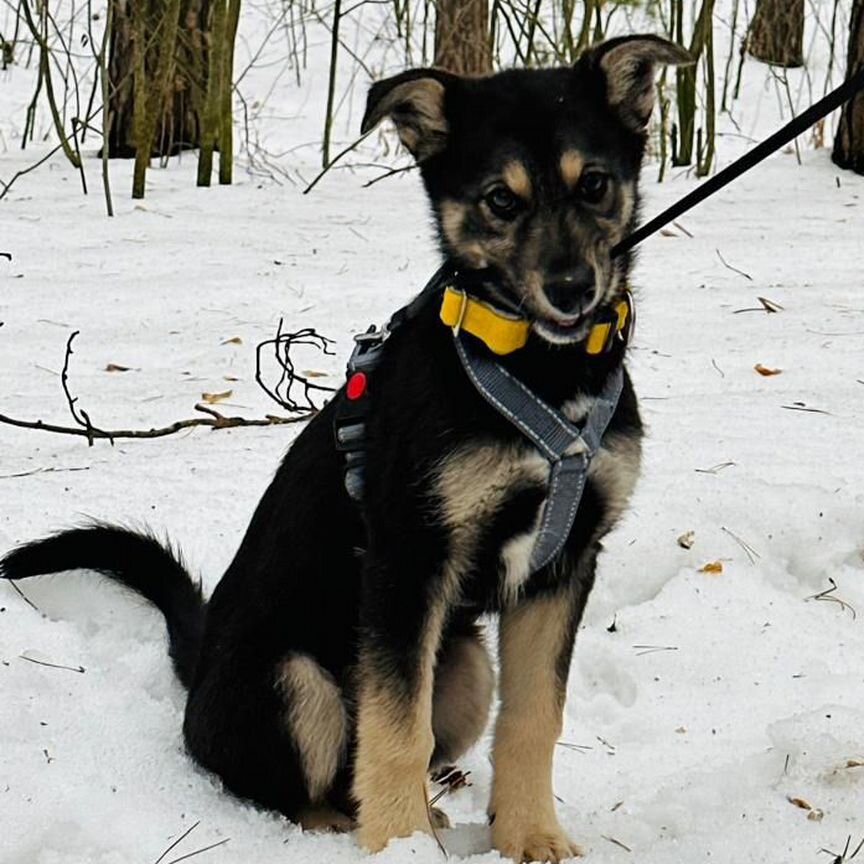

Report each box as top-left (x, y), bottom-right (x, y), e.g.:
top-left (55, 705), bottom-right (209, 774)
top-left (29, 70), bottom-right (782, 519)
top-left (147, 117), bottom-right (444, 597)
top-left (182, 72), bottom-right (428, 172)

top-left (354, 560), bottom-right (447, 852)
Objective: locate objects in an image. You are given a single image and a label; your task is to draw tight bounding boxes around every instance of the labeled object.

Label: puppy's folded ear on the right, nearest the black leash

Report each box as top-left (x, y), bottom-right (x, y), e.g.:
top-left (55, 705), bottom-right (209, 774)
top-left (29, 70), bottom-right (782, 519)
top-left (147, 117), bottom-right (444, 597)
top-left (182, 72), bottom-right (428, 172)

top-left (580, 35), bottom-right (695, 132)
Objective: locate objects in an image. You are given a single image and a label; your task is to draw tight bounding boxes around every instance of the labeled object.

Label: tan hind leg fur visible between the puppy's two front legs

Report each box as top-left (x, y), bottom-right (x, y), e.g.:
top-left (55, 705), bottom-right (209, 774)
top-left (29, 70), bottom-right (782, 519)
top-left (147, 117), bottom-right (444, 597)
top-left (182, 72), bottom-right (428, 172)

top-left (432, 636), bottom-right (495, 767)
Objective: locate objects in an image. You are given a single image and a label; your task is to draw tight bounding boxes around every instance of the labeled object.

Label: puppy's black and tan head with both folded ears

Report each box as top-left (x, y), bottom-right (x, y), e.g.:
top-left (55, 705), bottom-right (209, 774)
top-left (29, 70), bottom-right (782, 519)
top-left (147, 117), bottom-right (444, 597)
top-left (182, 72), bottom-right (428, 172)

top-left (363, 36), bottom-right (691, 344)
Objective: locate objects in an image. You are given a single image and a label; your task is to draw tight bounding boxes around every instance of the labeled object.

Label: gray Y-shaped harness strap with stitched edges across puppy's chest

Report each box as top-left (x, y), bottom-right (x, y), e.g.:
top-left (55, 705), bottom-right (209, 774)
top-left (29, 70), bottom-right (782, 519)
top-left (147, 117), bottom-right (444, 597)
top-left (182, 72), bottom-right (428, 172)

top-left (453, 334), bottom-right (624, 573)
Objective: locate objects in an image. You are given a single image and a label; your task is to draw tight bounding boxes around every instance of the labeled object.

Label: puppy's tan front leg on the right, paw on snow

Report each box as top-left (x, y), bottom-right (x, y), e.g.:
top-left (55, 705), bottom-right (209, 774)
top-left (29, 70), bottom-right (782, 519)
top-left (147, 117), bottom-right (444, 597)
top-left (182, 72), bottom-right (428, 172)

top-left (490, 584), bottom-right (584, 862)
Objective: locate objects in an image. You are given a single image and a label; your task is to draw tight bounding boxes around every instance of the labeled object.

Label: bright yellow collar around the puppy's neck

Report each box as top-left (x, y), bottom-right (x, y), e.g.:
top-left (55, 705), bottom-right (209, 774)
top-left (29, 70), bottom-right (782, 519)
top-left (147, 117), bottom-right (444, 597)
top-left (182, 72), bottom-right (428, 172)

top-left (441, 286), bottom-right (633, 354)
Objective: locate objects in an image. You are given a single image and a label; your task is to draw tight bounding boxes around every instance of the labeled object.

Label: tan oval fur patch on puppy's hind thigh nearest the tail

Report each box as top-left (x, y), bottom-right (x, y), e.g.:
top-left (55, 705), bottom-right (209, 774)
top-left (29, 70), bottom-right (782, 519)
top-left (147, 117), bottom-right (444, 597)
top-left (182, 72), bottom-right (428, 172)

top-left (277, 654), bottom-right (348, 802)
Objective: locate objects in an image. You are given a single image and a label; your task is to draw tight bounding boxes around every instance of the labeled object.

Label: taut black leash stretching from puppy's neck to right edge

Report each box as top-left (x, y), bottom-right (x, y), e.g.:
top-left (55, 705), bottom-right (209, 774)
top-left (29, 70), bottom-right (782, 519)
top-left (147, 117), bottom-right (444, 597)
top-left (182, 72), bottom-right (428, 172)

top-left (612, 67), bottom-right (864, 258)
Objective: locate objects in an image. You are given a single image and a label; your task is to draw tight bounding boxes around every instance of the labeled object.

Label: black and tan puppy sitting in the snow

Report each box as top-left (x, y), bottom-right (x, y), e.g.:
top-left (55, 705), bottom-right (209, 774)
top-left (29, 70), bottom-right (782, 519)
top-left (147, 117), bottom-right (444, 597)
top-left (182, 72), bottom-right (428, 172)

top-left (0, 36), bottom-right (690, 862)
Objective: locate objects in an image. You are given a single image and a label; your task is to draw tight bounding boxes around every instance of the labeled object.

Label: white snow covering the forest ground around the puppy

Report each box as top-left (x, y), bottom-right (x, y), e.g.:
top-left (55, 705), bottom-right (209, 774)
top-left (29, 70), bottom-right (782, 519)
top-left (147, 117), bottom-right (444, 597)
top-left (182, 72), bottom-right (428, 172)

top-left (0, 7), bottom-right (864, 864)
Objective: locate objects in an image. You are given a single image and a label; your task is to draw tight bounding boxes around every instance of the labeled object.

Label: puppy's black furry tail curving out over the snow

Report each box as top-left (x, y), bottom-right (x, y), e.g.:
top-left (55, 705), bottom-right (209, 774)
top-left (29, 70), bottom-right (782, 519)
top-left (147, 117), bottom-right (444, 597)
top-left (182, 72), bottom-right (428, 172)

top-left (0, 524), bottom-right (206, 688)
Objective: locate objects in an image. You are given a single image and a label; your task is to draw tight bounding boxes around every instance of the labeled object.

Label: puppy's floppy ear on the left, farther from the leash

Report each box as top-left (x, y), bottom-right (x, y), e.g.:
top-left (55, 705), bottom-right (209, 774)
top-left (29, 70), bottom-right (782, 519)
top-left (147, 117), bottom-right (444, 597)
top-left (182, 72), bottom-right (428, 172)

top-left (361, 69), bottom-right (456, 162)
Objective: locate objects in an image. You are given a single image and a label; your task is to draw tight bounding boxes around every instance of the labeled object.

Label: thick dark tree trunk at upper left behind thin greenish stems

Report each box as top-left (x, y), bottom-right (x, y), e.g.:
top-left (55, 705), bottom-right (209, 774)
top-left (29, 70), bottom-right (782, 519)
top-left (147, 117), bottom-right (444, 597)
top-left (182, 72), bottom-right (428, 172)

top-left (108, 0), bottom-right (210, 158)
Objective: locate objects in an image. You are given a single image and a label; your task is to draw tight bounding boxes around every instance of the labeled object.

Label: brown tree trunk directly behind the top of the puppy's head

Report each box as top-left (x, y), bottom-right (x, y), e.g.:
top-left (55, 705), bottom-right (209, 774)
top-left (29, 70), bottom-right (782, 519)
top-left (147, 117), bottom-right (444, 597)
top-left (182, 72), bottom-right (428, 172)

top-left (435, 0), bottom-right (492, 75)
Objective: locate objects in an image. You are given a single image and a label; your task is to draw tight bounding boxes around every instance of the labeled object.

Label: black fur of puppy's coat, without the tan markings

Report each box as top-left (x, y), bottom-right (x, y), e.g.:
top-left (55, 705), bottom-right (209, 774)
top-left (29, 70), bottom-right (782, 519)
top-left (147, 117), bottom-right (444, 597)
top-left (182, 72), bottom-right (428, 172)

top-left (0, 33), bottom-right (688, 855)
